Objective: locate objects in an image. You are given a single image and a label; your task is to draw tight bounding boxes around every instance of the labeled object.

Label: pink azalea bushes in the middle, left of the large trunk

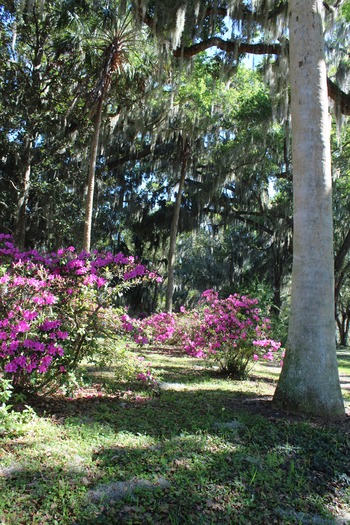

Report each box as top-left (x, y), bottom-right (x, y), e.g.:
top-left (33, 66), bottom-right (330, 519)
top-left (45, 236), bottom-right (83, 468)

top-left (133, 290), bottom-right (283, 378)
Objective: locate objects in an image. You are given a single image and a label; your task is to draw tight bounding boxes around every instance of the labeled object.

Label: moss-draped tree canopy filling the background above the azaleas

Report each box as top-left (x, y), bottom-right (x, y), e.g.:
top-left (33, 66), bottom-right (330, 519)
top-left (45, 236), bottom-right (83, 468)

top-left (0, 0), bottom-right (350, 418)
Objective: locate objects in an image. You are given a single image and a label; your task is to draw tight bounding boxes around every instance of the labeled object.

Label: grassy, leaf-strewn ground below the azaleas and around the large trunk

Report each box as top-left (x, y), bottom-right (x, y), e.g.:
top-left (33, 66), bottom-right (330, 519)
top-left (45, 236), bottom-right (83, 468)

top-left (0, 351), bottom-right (350, 525)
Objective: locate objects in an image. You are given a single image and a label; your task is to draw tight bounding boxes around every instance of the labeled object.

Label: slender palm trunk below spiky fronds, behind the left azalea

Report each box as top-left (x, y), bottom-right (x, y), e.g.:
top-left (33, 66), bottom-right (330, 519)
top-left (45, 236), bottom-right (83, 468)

top-left (83, 96), bottom-right (103, 252)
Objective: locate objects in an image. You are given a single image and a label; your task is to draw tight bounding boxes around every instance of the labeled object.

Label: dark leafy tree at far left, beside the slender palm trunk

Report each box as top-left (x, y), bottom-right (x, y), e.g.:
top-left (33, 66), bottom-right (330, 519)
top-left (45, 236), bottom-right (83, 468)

top-left (0, 2), bottom-right (91, 246)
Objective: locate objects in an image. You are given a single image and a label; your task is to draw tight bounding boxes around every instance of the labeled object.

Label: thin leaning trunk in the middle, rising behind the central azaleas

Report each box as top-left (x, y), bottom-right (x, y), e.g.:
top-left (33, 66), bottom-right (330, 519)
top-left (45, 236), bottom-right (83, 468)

top-left (165, 138), bottom-right (189, 313)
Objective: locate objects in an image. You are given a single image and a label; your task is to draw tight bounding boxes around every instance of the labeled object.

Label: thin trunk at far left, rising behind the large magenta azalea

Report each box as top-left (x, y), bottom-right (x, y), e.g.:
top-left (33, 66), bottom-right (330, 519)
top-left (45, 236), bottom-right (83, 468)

top-left (15, 136), bottom-right (33, 251)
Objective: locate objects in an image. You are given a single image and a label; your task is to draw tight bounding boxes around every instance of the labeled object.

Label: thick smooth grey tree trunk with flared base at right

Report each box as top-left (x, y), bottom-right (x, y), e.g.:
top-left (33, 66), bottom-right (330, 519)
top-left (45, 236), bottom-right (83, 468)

top-left (274, 0), bottom-right (344, 417)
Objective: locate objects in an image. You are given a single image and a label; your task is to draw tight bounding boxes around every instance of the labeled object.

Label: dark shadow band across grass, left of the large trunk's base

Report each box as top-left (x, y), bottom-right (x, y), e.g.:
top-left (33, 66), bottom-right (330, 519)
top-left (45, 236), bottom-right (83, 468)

top-left (25, 388), bottom-right (270, 438)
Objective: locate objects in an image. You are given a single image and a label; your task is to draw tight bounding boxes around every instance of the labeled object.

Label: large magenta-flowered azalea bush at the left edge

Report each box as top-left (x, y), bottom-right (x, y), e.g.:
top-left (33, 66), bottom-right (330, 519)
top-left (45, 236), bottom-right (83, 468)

top-left (0, 234), bottom-right (158, 389)
